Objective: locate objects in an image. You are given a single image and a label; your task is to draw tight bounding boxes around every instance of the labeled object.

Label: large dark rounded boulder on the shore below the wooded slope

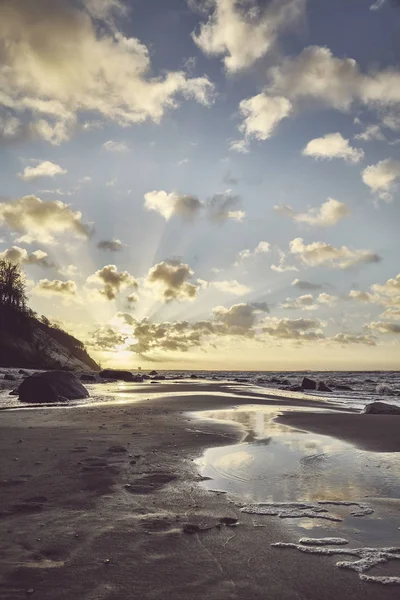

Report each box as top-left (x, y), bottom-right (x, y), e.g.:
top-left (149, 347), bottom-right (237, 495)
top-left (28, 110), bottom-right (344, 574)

top-left (18, 371), bottom-right (89, 403)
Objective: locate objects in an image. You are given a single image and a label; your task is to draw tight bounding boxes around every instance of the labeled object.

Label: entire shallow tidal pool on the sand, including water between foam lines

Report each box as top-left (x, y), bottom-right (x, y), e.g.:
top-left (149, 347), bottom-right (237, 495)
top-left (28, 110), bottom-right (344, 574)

top-left (196, 405), bottom-right (400, 545)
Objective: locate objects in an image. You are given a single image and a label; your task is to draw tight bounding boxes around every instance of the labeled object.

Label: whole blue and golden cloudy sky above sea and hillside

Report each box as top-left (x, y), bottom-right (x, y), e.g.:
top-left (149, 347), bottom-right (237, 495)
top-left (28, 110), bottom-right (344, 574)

top-left (0, 0), bottom-right (400, 370)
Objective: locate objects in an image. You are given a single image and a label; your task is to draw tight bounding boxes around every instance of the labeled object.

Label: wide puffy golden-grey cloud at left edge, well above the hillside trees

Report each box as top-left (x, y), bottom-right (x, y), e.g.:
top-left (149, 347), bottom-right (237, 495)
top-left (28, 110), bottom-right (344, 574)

top-left (0, 196), bottom-right (90, 243)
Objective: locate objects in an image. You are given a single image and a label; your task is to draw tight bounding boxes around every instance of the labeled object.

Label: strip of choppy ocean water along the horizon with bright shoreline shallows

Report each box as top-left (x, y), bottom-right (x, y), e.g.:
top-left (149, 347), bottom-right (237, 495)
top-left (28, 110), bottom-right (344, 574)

top-left (0, 369), bottom-right (400, 409)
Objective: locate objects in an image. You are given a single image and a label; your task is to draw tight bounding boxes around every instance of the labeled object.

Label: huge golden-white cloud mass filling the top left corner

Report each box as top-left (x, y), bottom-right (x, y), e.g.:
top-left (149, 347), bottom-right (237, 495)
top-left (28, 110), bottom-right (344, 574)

top-left (0, 0), bottom-right (213, 144)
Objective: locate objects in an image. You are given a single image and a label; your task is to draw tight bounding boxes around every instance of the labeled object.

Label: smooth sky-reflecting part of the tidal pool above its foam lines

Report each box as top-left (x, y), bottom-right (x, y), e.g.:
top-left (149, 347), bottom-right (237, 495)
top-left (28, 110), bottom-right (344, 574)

top-left (199, 406), bottom-right (400, 502)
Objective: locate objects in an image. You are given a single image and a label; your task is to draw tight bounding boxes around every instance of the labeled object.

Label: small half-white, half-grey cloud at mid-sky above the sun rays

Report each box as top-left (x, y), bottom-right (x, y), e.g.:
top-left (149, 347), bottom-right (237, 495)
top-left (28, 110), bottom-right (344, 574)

top-left (144, 190), bottom-right (204, 221)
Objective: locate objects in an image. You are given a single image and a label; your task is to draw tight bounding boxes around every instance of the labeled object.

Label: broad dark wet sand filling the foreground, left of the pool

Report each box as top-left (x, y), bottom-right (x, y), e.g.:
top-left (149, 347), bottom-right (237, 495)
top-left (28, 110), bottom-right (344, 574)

top-left (0, 382), bottom-right (399, 600)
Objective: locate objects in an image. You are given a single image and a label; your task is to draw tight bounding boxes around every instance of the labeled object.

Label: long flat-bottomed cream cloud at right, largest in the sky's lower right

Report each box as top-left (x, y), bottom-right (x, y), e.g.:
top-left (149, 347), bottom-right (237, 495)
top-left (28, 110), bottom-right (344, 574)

top-left (290, 238), bottom-right (381, 269)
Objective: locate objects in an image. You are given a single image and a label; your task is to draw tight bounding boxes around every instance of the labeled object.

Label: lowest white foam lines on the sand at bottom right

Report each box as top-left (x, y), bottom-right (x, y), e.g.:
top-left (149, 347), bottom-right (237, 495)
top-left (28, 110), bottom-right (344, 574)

top-left (271, 538), bottom-right (400, 585)
